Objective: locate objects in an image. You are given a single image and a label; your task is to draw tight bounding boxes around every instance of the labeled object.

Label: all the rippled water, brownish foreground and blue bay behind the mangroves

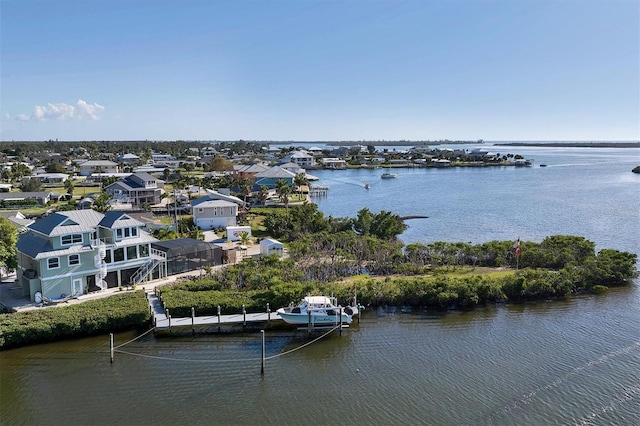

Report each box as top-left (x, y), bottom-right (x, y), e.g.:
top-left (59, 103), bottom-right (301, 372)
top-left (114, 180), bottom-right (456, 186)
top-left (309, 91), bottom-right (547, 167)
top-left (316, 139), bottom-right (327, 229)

top-left (0, 147), bottom-right (640, 425)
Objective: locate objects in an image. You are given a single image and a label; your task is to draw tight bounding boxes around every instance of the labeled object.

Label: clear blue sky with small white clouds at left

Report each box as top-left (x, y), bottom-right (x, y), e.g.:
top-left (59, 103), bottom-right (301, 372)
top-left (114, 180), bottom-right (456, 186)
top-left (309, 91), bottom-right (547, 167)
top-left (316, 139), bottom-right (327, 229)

top-left (0, 0), bottom-right (640, 141)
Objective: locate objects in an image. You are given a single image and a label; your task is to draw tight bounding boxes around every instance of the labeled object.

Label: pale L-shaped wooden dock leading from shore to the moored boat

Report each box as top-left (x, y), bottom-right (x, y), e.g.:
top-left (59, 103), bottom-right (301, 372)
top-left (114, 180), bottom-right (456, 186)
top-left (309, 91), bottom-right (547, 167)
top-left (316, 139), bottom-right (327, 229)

top-left (147, 293), bottom-right (284, 333)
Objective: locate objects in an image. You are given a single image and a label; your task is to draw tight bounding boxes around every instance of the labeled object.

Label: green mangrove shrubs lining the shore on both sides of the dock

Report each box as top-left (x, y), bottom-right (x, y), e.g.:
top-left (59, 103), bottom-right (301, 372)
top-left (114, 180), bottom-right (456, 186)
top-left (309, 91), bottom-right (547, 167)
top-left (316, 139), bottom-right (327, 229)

top-left (0, 204), bottom-right (638, 349)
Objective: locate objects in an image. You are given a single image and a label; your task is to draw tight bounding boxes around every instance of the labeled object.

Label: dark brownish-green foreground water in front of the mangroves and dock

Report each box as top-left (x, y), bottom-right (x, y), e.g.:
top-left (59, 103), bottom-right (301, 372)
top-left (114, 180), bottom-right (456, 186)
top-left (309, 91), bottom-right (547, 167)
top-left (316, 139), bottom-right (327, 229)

top-left (0, 286), bottom-right (640, 425)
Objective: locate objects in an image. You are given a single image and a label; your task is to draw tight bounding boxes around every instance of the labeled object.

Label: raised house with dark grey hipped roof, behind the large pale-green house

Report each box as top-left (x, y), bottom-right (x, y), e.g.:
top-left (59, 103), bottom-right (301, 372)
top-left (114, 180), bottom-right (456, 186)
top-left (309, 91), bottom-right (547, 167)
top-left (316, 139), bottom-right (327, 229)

top-left (104, 172), bottom-right (164, 207)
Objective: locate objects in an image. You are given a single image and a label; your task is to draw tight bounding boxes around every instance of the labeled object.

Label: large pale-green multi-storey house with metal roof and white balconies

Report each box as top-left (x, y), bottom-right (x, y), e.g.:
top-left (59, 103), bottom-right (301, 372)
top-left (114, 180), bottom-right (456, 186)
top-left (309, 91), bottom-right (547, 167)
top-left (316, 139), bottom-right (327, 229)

top-left (16, 210), bottom-right (166, 301)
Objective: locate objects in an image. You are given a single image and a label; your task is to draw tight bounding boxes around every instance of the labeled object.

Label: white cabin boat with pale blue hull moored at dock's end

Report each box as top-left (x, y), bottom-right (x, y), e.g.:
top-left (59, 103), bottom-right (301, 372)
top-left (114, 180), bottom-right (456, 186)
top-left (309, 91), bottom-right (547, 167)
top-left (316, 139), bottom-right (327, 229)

top-left (276, 296), bottom-right (357, 325)
